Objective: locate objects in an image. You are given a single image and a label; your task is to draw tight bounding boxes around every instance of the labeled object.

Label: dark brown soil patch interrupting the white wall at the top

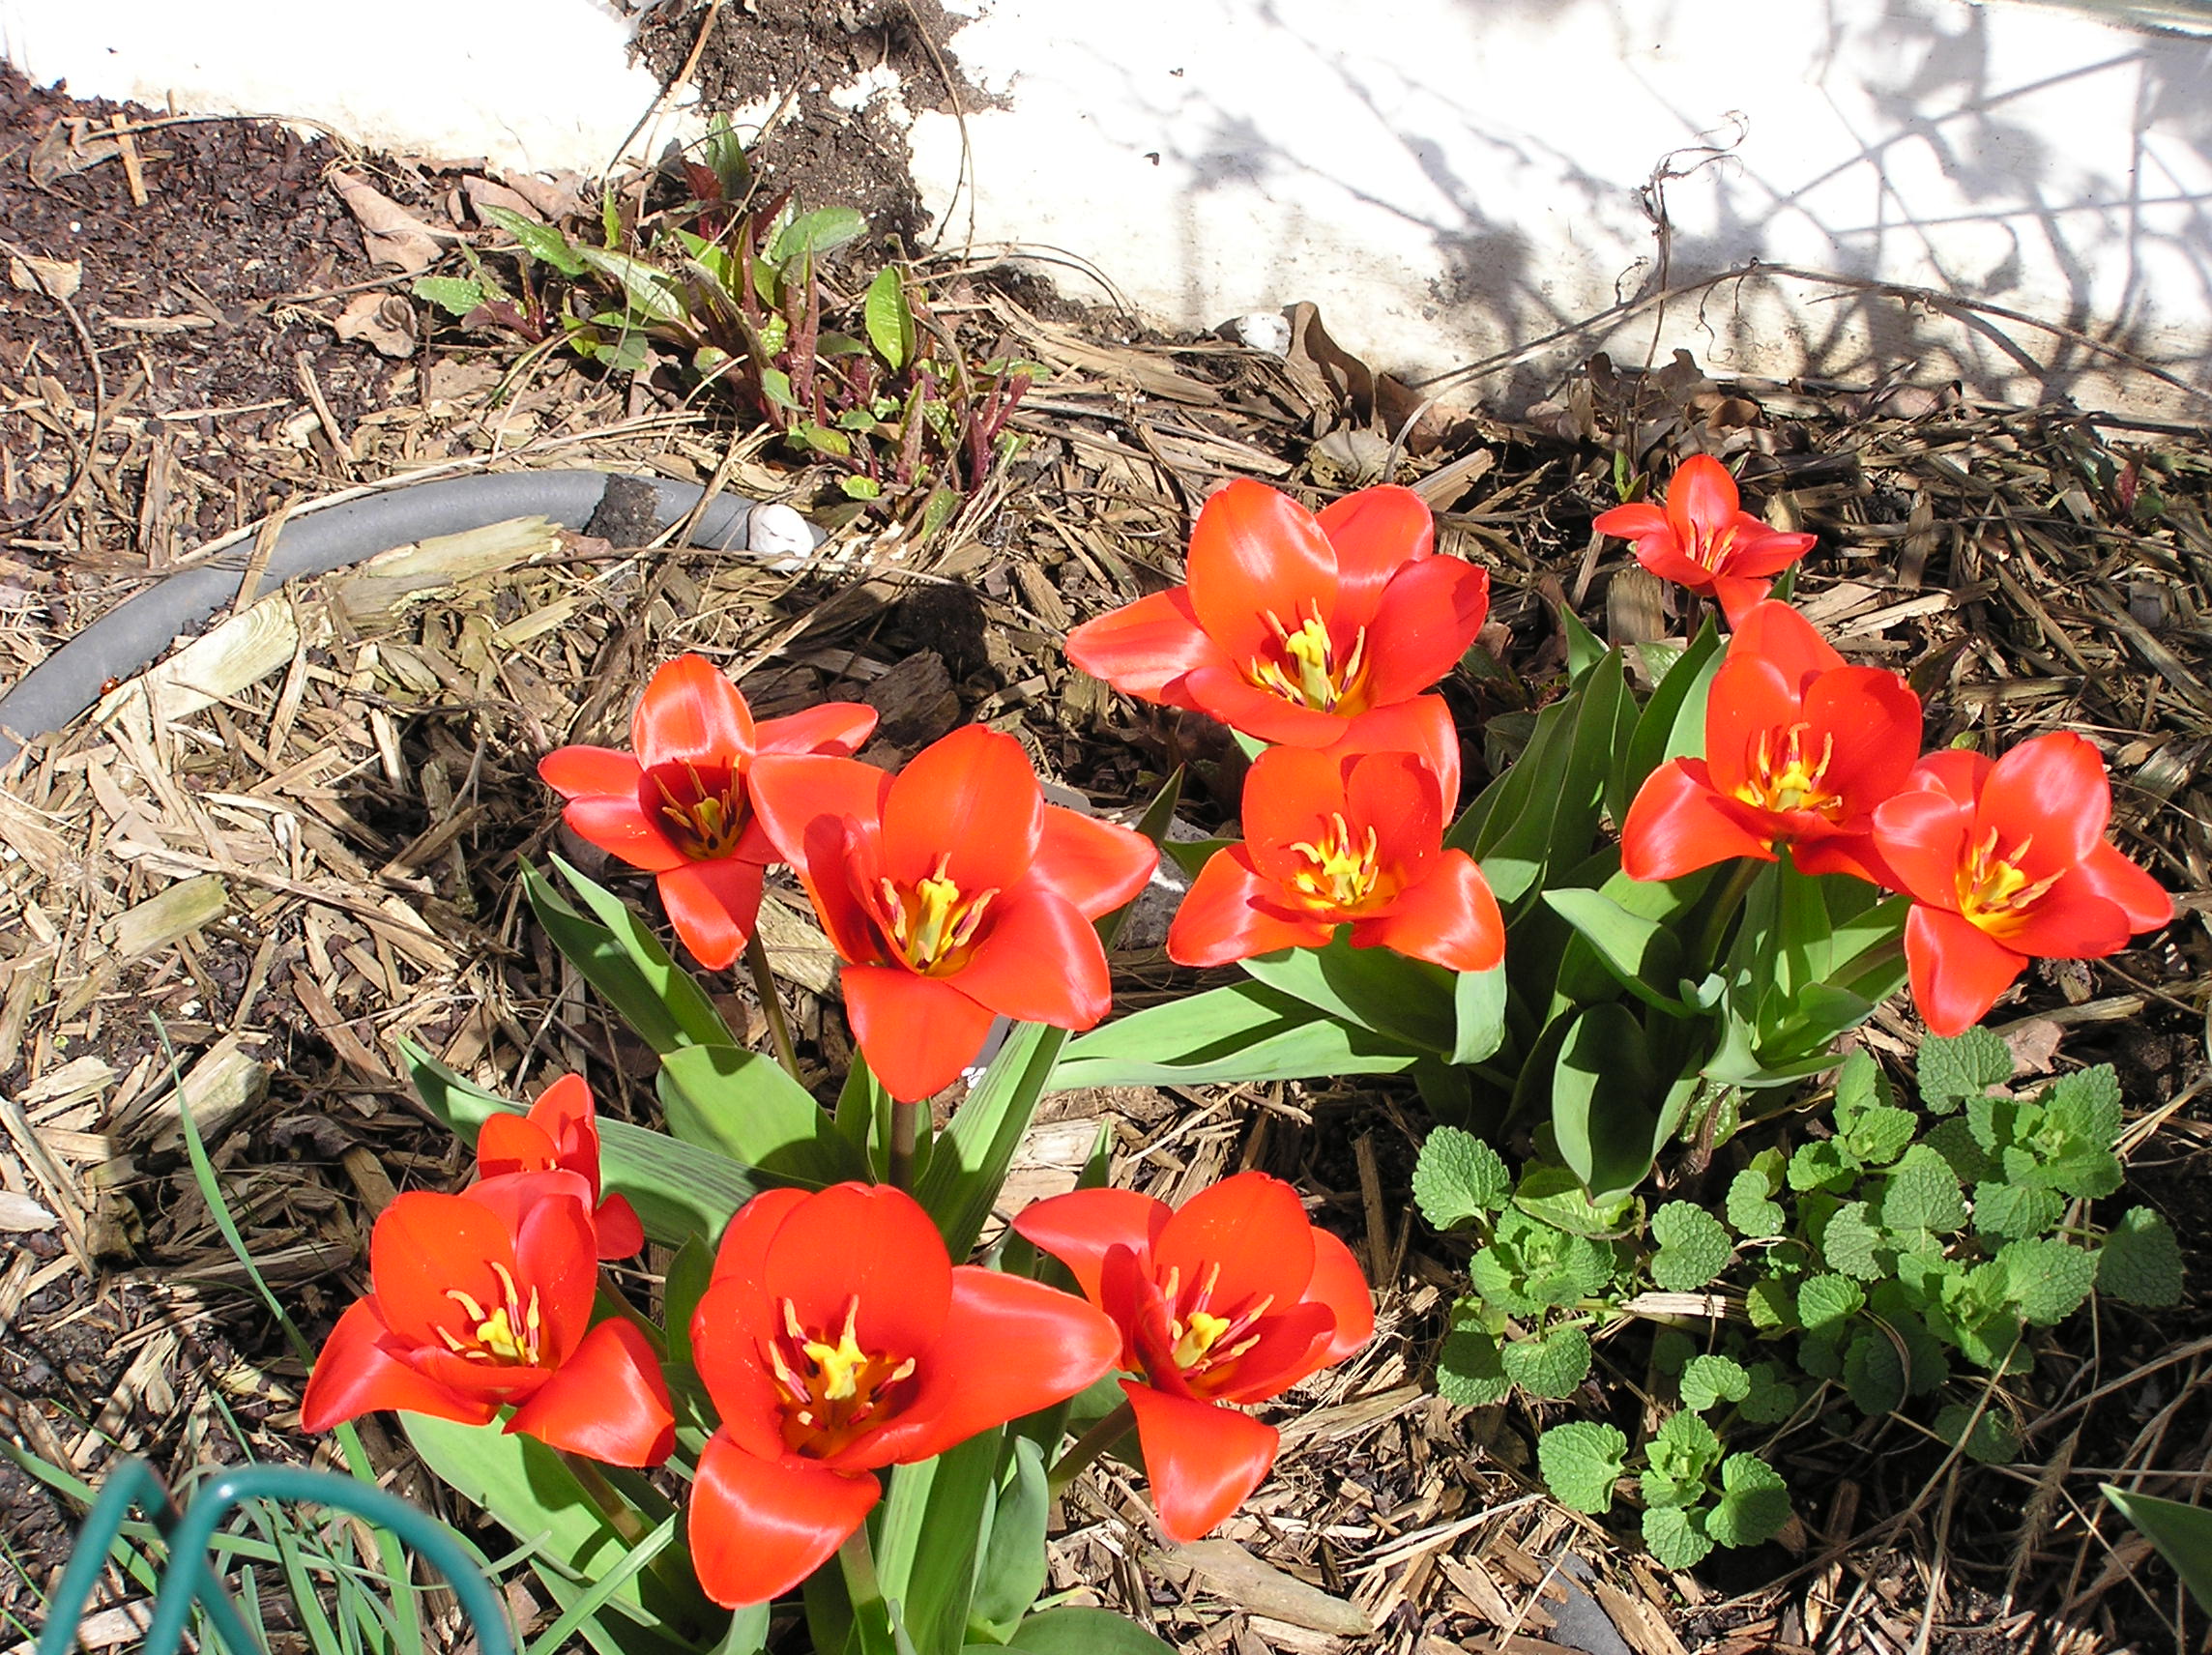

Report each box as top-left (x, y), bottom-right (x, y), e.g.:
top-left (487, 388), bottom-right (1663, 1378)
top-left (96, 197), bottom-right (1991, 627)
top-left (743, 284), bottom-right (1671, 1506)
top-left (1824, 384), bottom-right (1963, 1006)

top-left (637, 0), bottom-right (986, 247)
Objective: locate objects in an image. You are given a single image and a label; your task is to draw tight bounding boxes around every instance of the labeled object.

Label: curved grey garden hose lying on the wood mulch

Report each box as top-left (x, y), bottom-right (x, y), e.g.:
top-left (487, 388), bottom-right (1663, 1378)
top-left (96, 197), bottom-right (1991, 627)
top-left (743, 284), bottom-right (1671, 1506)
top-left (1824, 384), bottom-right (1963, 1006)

top-left (0, 472), bottom-right (792, 766)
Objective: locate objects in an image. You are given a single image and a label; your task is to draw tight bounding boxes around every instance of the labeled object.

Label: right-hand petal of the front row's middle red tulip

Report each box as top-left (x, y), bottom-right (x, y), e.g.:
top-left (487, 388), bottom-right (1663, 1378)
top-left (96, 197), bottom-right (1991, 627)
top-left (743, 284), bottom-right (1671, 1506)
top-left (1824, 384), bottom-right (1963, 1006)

top-left (869, 1265), bottom-right (1121, 1465)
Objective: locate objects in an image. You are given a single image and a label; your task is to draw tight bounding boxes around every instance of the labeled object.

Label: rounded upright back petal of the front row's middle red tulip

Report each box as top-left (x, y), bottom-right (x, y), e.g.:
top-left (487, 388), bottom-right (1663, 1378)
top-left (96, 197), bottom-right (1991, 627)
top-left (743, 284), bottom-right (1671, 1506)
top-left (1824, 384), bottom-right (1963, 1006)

top-left (761, 1183), bottom-right (953, 1358)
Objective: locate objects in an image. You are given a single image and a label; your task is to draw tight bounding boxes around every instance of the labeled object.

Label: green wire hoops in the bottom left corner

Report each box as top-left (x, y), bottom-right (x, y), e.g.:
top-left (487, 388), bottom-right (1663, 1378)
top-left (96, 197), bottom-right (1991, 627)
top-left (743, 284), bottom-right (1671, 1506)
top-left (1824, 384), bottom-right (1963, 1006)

top-left (38, 1461), bottom-right (515, 1655)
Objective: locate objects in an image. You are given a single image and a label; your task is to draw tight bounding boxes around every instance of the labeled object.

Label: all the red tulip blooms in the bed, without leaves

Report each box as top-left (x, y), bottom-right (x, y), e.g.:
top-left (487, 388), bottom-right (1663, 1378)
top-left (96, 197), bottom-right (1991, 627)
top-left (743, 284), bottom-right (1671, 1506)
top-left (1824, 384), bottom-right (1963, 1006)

top-left (303, 460), bottom-right (2170, 1604)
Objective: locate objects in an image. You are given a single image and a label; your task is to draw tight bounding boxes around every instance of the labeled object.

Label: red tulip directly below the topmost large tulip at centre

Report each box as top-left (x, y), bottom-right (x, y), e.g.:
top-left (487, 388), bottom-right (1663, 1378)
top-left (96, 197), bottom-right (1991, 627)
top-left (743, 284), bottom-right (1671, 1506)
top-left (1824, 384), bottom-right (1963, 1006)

top-left (1168, 695), bottom-right (1506, 972)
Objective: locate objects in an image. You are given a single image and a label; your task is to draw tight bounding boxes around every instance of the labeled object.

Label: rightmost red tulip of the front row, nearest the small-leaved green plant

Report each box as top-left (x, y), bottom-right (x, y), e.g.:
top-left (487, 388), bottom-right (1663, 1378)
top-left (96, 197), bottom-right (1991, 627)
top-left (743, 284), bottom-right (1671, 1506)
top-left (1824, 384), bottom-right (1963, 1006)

top-left (1013, 1173), bottom-right (1376, 1540)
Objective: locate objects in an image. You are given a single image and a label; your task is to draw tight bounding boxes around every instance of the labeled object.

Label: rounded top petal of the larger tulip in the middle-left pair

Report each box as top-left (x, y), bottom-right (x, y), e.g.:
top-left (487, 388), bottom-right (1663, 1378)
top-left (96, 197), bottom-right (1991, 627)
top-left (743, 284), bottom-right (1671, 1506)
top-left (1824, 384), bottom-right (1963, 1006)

top-left (883, 723), bottom-right (1044, 896)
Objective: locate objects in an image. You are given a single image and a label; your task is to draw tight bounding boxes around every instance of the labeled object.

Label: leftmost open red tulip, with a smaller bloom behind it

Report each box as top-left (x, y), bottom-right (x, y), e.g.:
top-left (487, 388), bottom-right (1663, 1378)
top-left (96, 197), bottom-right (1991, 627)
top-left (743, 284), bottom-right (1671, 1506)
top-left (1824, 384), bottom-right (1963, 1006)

top-left (299, 1173), bottom-right (675, 1465)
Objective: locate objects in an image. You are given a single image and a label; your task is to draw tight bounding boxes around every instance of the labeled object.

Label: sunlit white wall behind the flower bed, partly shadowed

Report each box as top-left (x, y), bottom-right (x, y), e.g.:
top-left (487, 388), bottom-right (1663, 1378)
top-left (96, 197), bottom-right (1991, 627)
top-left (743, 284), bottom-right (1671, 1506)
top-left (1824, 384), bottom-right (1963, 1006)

top-left (0, 0), bottom-right (2212, 421)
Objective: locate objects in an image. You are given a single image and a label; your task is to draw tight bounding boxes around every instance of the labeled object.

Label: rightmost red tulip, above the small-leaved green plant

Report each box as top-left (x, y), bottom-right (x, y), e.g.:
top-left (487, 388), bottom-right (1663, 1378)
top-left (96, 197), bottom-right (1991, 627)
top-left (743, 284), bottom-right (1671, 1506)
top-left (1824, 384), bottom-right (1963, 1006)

top-left (1874, 730), bottom-right (2174, 1035)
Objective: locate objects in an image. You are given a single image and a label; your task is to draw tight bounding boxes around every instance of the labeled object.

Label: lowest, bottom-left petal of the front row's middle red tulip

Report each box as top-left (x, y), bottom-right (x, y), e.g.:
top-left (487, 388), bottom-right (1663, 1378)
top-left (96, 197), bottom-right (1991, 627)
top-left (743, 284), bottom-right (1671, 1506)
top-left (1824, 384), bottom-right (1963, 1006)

top-left (684, 1432), bottom-right (881, 1609)
